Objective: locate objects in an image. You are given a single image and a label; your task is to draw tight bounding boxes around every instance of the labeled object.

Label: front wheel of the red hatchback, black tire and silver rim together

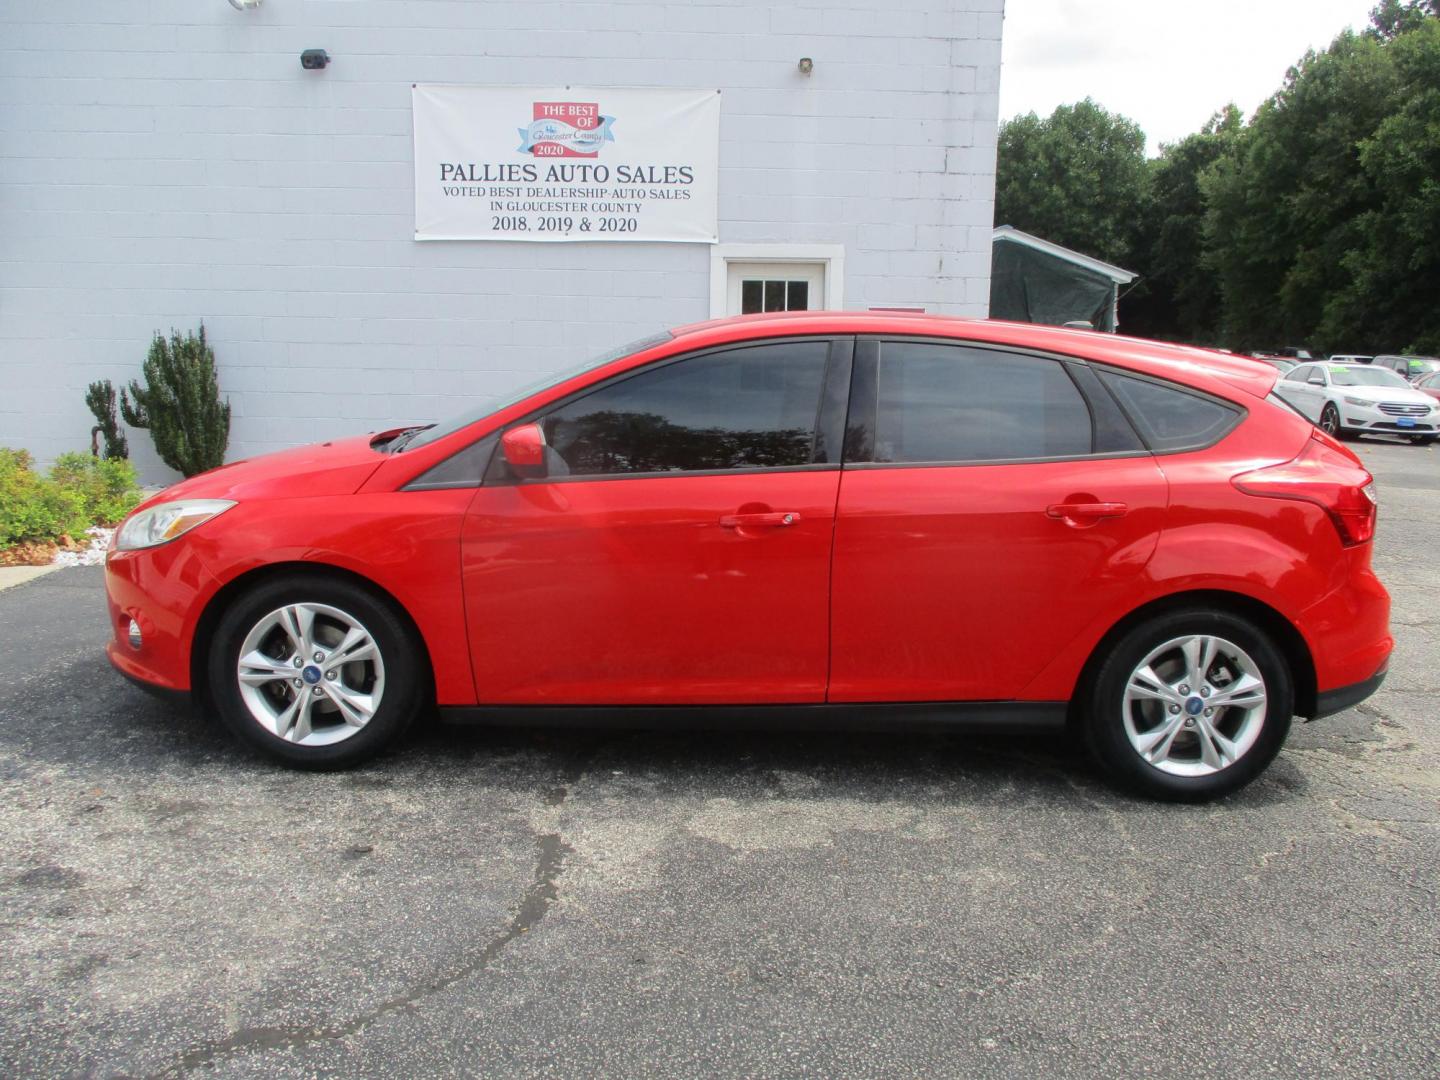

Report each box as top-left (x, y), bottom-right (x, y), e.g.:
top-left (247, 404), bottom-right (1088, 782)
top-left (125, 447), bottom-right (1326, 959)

top-left (209, 575), bottom-right (425, 769)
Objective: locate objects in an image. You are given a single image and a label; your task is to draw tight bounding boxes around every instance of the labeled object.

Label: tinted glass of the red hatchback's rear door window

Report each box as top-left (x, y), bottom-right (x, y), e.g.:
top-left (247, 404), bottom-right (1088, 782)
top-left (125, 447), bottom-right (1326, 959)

top-left (874, 341), bottom-right (1094, 462)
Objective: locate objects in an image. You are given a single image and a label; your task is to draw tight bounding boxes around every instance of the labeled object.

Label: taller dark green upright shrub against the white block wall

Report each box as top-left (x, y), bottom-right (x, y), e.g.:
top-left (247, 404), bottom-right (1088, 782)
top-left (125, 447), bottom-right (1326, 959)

top-left (120, 324), bottom-right (230, 477)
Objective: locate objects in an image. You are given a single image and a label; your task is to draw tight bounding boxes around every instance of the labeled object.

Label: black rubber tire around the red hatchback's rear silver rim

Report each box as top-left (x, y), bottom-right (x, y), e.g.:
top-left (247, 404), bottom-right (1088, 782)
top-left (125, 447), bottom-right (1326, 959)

top-left (1077, 609), bottom-right (1295, 802)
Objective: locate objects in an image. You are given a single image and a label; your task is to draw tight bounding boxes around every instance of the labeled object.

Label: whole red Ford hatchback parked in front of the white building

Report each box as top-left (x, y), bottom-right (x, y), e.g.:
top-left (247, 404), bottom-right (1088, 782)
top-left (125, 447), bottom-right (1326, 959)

top-left (107, 312), bottom-right (1391, 799)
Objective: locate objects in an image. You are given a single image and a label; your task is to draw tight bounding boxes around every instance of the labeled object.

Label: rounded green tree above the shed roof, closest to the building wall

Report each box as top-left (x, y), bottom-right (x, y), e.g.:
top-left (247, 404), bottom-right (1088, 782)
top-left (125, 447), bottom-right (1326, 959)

top-left (995, 98), bottom-right (1149, 265)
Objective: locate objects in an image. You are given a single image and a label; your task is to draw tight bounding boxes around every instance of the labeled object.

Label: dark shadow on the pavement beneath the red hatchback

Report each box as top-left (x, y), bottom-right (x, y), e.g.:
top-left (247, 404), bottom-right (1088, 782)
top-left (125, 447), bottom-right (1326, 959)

top-left (19, 685), bottom-right (1306, 812)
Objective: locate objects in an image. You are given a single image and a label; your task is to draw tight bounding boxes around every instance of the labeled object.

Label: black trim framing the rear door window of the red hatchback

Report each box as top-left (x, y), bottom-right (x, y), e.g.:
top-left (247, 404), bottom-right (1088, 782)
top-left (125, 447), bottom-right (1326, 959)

top-left (845, 334), bottom-right (1172, 469)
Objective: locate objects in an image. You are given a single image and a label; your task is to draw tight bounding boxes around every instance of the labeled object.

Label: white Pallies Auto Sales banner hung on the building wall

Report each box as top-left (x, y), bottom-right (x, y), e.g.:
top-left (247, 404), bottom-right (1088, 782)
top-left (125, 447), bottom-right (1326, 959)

top-left (412, 86), bottom-right (720, 243)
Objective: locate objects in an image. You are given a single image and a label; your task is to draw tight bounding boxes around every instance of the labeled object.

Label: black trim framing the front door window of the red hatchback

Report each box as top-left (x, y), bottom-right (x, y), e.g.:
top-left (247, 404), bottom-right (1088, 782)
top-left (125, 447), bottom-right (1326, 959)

top-left (480, 334), bottom-right (855, 488)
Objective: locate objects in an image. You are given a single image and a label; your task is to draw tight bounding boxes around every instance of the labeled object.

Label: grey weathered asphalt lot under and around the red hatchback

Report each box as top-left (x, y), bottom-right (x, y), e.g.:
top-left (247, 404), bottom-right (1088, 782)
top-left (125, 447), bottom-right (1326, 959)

top-left (0, 442), bottom-right (1440, 1080)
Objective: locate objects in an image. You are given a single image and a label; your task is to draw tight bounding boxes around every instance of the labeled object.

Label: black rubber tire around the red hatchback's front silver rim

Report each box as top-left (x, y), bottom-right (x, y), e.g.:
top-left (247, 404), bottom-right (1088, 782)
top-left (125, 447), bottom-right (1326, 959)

top-left (206, 573), bottom-right (429, 769)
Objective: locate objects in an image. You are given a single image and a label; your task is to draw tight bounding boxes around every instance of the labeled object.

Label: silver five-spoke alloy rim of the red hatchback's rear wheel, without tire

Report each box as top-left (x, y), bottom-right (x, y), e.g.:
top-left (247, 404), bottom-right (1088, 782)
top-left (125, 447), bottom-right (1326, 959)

top-left (1122, 634), bottom-right (1267, 776)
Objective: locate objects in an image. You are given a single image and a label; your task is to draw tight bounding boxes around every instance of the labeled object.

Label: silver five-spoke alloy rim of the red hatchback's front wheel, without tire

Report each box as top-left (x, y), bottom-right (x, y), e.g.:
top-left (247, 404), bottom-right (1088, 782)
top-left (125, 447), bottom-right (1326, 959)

top-left (235, 603), bottom-right (384, 746)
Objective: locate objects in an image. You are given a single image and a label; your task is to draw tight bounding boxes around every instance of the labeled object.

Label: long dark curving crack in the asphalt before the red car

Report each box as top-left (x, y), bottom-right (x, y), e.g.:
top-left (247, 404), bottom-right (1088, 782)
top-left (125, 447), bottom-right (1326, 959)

top-left (151, 756), bottom-right (589, 1077)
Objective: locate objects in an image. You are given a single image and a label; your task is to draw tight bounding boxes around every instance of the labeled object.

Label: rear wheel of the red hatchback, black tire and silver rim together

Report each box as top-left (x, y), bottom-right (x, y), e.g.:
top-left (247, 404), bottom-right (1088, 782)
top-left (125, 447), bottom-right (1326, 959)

top-left (1081, 609), bottom-right (1295, 802)
